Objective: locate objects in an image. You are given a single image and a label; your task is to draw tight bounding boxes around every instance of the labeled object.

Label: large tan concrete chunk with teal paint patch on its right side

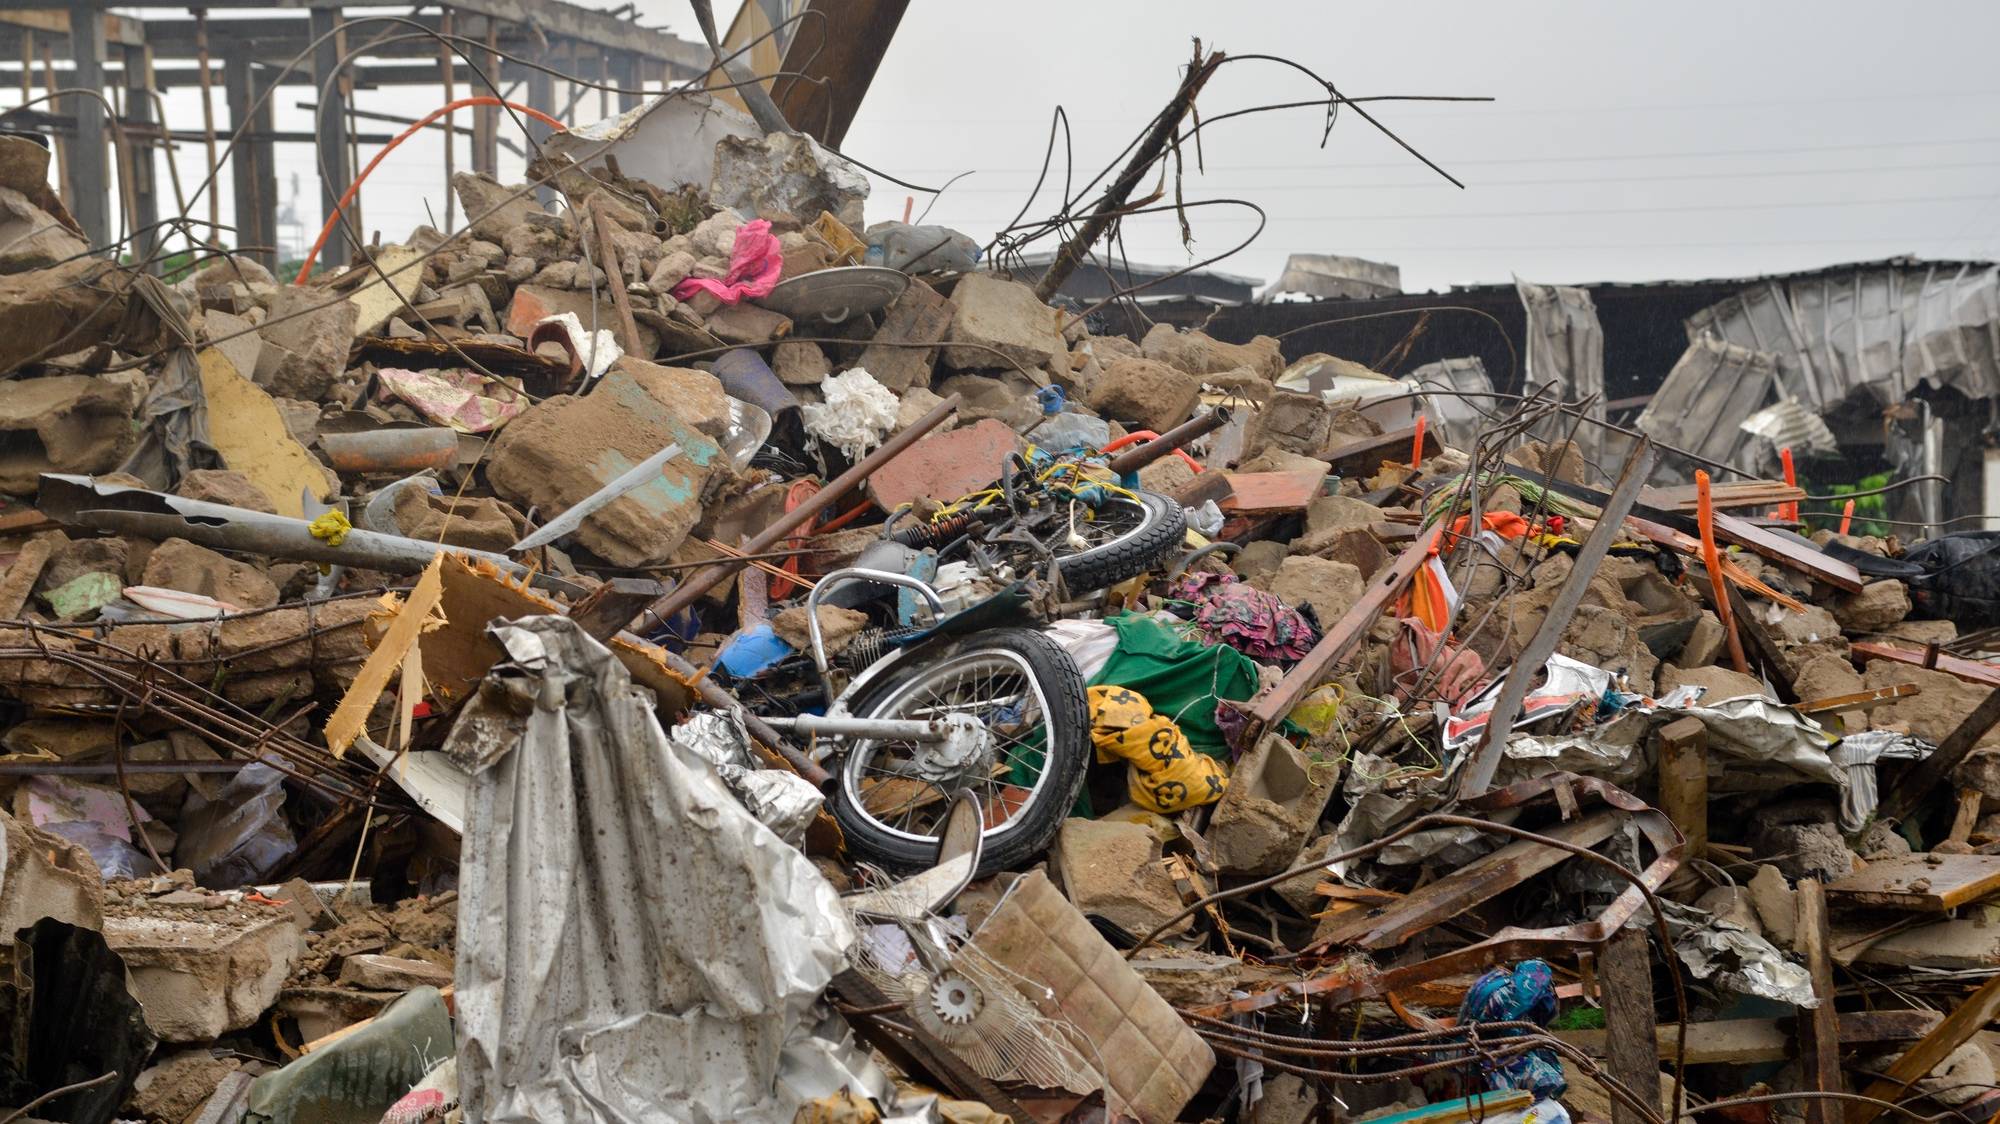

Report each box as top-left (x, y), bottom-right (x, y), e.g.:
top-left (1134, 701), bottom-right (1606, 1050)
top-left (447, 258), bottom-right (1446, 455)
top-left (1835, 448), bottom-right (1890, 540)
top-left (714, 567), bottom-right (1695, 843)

top-left (486, 364), bottom-right (728, 566)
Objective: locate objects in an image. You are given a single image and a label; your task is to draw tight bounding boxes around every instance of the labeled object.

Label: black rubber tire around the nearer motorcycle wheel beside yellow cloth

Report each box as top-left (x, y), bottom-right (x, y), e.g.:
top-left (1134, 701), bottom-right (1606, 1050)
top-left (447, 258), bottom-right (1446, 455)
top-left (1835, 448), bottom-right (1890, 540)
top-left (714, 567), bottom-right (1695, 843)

top-left (832, 628), bottom-right (1092, 876)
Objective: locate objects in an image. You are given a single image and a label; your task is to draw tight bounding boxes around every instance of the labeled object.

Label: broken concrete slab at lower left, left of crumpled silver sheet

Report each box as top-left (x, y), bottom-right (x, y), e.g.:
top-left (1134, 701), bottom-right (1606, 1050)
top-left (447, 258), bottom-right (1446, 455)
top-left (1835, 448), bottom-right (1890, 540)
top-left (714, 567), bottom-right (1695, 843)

top-left (104, 902), bottom-right (306, 1042)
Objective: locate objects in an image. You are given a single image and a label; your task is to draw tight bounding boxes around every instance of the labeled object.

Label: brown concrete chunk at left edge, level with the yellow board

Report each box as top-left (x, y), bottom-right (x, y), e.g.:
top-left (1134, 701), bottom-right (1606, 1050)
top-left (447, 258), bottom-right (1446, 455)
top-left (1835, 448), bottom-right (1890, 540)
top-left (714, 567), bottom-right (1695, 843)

top-left (0, 372), bottom-right (146, 496)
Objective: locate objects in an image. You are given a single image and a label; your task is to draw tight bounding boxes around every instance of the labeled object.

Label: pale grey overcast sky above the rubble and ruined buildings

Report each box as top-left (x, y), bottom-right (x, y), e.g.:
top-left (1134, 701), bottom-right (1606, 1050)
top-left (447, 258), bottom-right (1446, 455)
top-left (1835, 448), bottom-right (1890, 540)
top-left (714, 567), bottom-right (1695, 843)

top-left (246, 0), bottom-right (2000, 290)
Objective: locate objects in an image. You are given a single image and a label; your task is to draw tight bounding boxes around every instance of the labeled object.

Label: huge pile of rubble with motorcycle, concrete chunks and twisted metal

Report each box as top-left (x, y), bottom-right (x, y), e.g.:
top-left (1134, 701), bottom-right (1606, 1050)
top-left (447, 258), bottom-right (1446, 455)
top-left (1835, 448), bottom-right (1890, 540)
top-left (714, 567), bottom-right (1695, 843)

top-left (0, 83), bottom-right (2000, 1124)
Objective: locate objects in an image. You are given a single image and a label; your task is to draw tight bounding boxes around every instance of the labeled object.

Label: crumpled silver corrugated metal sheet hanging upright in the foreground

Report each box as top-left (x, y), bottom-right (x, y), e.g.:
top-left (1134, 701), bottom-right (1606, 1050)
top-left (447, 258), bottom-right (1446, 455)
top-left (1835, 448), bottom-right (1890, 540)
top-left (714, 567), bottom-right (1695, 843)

top-left (448, 616), bottom-right (856, 1124)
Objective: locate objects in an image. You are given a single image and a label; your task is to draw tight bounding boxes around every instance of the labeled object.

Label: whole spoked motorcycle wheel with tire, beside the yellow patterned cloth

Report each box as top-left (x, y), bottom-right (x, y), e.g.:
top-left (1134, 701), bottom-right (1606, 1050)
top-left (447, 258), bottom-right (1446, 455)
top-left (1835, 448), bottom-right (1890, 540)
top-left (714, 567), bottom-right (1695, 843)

top-left (832, 628), bottom-right (1090, 874)
